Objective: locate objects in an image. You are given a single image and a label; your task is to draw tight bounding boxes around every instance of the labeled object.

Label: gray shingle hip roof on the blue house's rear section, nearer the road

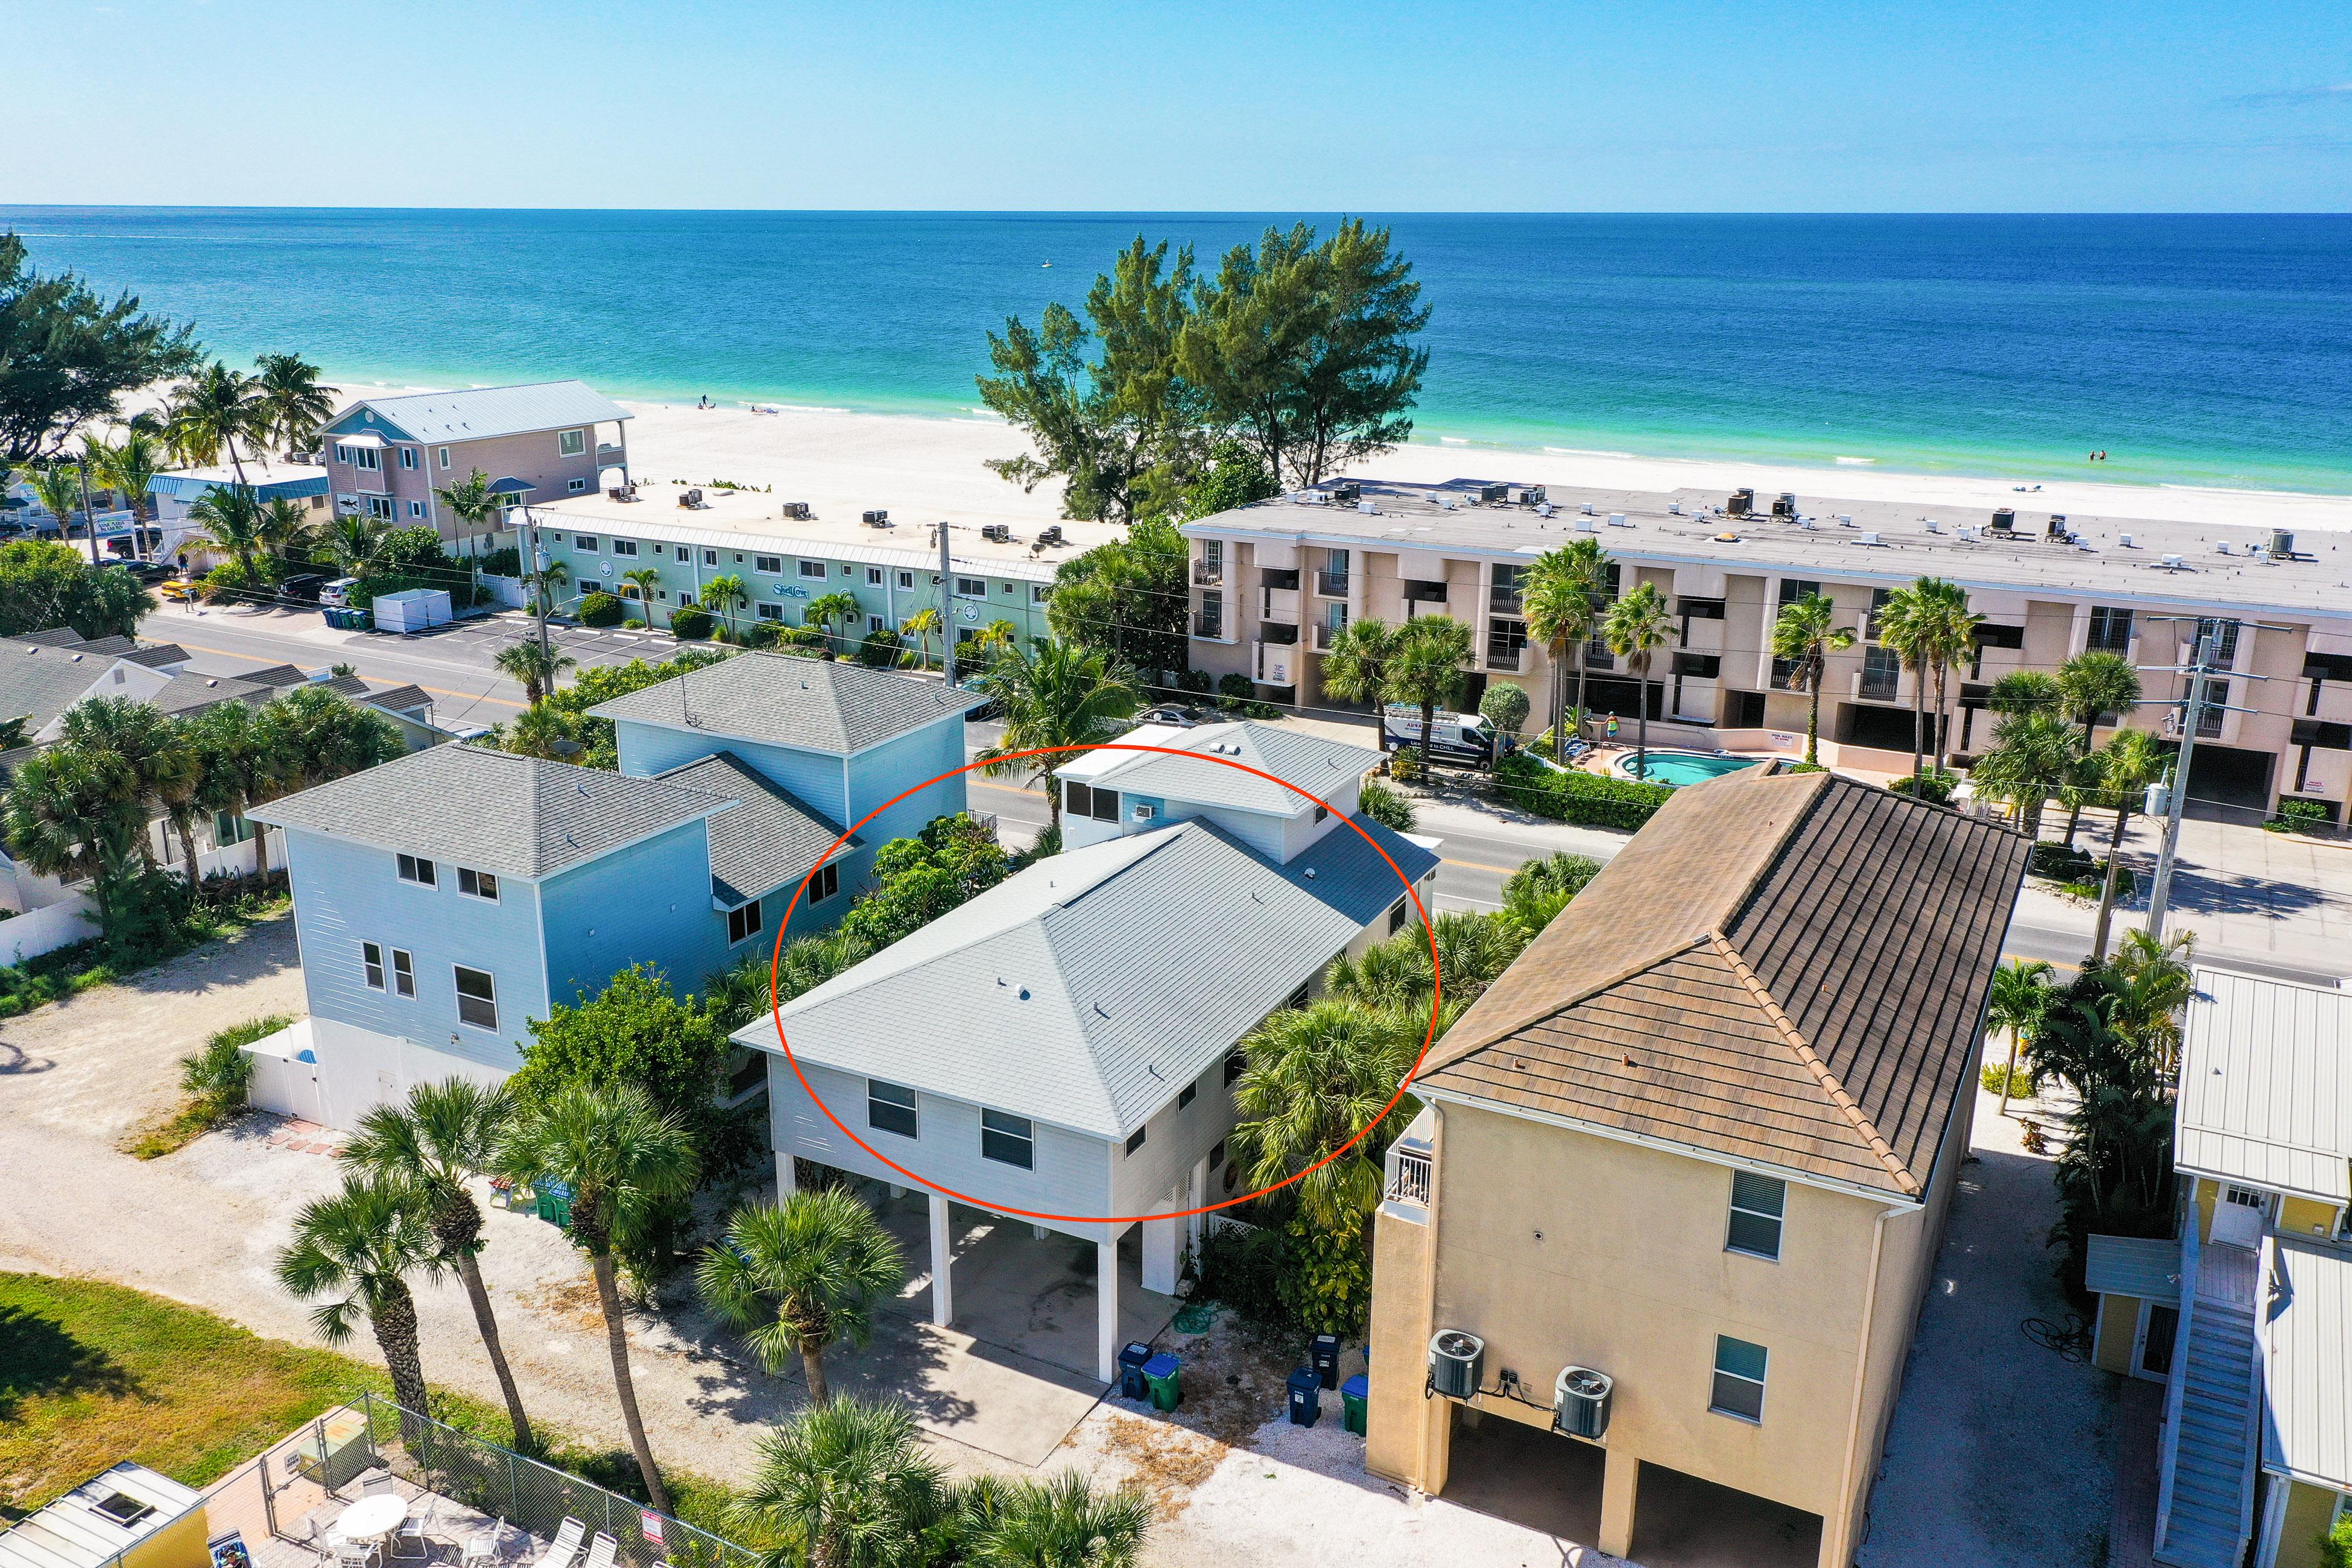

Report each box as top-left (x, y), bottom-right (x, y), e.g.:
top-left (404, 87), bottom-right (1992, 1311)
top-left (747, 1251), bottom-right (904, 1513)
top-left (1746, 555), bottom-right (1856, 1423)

top-left (588, 651), bottom-right (973, 771)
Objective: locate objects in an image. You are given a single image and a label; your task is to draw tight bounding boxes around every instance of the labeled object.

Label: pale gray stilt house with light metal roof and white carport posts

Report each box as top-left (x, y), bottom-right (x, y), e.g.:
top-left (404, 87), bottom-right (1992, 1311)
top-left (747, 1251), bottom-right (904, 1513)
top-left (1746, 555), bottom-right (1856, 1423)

top-left (736, 724), bottom-right (1437, 1377)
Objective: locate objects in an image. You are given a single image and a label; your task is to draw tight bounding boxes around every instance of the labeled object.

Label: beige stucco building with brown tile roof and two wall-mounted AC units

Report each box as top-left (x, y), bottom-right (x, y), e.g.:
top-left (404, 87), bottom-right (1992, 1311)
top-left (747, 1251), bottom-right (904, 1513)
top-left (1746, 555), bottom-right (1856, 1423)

top-left (1367, 769), bottom-right (2025, 1566)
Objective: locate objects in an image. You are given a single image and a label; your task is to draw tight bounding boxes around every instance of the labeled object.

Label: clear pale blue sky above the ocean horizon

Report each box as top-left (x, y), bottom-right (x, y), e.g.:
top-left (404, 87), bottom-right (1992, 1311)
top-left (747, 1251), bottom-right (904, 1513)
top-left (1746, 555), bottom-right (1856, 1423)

top-left (18, 0), bottom-right (2352, 212)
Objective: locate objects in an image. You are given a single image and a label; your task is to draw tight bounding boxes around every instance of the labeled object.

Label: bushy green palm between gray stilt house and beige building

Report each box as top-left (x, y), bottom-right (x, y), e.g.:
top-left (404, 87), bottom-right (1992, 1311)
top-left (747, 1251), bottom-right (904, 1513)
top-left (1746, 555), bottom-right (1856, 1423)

top-left (1233, 997), bottom-right (1427, 1227)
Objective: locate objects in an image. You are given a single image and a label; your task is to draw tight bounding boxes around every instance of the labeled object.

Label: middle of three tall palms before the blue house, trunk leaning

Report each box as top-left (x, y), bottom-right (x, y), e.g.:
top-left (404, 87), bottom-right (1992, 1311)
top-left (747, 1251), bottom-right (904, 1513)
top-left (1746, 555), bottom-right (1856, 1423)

top-left (343, 1076), bottom-right (536, 1453)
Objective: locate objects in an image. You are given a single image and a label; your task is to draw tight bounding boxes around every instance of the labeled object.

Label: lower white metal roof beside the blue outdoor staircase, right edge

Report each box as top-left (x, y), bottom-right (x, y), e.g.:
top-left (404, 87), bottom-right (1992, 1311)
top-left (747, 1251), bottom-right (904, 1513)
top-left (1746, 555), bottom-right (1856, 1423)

top-left (2263, 1234), bottom-right (2352, 1493)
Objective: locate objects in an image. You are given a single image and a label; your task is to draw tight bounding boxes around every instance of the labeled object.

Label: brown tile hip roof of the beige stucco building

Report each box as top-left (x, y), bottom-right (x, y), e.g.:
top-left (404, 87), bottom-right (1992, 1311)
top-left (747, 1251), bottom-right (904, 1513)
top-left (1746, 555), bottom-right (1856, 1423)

top-left (1421, 769), bottom-right (2028, 1197)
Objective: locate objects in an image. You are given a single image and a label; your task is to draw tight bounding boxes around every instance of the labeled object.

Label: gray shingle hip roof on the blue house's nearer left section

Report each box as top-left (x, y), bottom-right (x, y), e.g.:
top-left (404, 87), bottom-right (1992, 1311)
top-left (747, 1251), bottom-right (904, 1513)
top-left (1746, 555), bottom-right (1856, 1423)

top-left (247, 745), bottom-right (732, 877)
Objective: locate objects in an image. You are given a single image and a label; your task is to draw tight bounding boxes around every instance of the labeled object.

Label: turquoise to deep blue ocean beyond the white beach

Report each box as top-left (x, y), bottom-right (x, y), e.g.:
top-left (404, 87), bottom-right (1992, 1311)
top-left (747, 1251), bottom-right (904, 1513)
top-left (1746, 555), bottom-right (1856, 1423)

top-left (0, 207), bottom-right (2352, 494)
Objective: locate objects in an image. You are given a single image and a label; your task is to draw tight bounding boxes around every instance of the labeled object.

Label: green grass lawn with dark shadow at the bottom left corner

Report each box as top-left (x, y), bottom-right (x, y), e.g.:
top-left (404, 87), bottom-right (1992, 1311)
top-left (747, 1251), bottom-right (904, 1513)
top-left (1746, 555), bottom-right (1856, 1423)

top-left (0, 1272), bottom-right (760, 1544)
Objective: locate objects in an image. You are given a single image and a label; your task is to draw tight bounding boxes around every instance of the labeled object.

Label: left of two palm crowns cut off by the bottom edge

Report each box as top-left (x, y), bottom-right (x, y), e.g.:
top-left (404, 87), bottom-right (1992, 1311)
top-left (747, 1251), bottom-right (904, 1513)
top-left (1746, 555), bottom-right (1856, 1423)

top-left (729, 1399), bottom-right (948, 1568)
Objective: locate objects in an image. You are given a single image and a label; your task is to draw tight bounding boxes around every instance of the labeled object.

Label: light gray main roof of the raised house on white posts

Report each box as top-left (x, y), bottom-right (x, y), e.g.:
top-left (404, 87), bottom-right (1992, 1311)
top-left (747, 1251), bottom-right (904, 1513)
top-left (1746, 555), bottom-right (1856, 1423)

top-left (736, 818), bottom-right (1437, 1138)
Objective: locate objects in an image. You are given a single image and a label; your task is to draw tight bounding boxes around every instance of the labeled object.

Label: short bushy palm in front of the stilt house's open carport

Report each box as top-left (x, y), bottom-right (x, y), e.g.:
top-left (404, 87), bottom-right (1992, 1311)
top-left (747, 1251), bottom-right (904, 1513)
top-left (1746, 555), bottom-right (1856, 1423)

top-left (696, 1187), bottom-right (906, 1403)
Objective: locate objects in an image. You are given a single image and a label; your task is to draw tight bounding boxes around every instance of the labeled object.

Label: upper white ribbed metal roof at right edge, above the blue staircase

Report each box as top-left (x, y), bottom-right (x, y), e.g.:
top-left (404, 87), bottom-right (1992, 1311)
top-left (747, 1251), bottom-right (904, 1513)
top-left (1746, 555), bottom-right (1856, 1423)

top-left (2173, 969), bottom-right (2352, 1204)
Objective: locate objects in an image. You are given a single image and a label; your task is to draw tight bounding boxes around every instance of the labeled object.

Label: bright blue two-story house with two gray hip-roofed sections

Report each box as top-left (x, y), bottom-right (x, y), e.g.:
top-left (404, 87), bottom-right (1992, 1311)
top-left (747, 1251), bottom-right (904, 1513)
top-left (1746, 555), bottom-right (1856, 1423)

top-left (249, 654), bottom-right (964, 1126)
